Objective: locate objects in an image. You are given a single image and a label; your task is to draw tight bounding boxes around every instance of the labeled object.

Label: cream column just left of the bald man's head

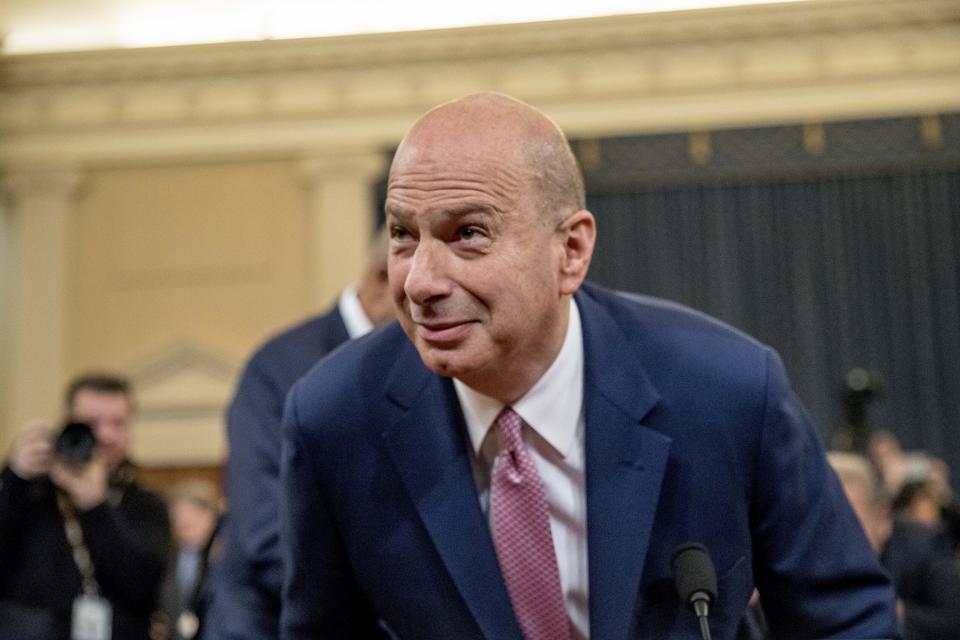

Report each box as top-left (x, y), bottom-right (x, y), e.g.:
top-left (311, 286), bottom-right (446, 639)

top-left (300, 151), bottom-right (386, 309)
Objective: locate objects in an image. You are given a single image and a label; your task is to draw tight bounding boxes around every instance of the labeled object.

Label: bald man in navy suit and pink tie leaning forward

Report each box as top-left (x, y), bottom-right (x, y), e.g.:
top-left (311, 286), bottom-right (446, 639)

top-left (281, 94), bottom-right (897, 640)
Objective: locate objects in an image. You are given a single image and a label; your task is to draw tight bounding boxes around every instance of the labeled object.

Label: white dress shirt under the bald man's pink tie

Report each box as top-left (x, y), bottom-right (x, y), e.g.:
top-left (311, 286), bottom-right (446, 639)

top-left (453, 300), bottom-right (590, 639)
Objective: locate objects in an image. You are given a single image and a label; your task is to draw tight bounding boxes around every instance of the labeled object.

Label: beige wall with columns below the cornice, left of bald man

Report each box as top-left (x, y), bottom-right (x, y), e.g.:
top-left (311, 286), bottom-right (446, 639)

top-left (0, 153), bottom-right (383, 465)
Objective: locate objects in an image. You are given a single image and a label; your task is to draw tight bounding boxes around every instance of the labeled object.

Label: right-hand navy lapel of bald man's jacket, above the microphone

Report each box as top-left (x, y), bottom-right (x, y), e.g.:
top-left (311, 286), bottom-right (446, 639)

top-left (577, 293), bottom-right (670, 640)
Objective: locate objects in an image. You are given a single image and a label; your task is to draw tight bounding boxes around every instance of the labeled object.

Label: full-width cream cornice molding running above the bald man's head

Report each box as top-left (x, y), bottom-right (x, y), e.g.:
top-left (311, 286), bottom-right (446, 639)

top-left (0, 0), bottom-right (960, 167)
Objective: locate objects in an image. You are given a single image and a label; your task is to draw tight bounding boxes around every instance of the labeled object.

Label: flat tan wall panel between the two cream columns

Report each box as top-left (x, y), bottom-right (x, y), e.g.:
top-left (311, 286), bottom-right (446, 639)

top-left (66, 162), bottom-right (312, 374)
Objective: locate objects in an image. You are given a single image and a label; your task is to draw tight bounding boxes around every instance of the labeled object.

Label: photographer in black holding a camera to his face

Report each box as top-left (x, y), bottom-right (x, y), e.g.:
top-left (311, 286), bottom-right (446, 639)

top-left (0, 375), bottom-right (170, 640)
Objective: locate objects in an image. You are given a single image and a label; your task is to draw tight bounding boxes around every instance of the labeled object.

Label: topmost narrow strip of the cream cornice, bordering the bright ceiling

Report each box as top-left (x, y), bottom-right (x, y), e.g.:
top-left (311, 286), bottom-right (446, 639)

top-left (0, 0), bottom-right (960, 87)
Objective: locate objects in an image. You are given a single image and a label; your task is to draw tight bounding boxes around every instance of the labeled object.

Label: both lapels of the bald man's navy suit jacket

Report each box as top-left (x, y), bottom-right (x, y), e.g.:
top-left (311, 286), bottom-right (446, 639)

top-left (383, 288), bottom-right (670, 640)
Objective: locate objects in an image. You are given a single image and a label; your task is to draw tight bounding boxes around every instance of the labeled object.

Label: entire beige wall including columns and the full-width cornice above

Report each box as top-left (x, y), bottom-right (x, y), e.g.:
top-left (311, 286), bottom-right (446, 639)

top-left (0, 0), bottom-right (960, 465)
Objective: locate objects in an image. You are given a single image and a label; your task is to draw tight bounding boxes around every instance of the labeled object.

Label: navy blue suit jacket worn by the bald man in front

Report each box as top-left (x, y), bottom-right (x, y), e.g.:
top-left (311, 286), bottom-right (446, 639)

top-left (281, 286), bottom-right (897, 640)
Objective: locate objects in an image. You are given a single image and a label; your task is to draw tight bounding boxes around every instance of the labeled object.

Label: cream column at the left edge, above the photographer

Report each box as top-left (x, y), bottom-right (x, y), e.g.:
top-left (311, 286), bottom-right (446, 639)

top-left (0, 169), bottom-right (80, 445)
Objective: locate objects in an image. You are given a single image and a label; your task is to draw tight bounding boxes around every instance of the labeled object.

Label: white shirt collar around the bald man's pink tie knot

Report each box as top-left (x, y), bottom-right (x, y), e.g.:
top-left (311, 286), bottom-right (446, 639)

top-left (453, 298), bottom-right (583, 457)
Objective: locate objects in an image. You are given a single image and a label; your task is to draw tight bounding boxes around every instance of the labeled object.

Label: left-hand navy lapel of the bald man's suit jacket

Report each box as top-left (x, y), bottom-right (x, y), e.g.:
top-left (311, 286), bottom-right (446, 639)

top-left (383, 345), bottom-right (521, 639)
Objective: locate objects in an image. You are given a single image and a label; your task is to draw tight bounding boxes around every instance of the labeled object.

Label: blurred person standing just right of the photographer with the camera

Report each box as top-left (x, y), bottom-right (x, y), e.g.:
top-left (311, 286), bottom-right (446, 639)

top-left (154, 480), bottom-right (222, 640)
